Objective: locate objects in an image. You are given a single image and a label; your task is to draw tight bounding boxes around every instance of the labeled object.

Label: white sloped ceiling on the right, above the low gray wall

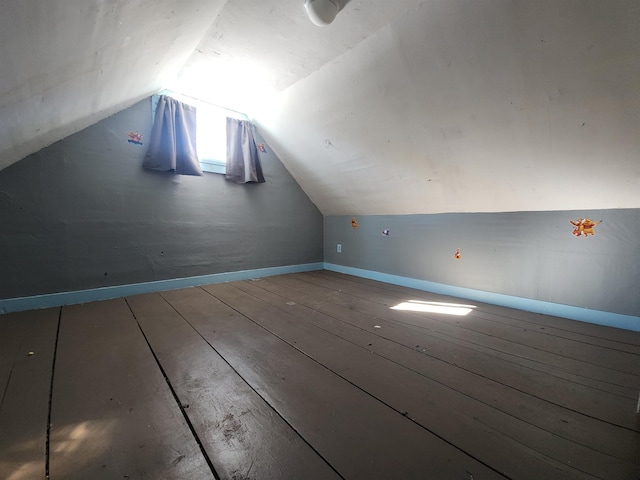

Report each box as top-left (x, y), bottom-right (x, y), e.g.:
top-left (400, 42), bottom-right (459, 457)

top-left (254, 0), bottom-right (640, 215)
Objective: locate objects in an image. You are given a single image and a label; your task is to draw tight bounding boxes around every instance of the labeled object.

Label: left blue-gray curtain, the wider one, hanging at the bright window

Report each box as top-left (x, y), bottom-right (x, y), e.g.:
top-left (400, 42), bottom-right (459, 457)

top-left (143, 95), bottom-right (202, 175)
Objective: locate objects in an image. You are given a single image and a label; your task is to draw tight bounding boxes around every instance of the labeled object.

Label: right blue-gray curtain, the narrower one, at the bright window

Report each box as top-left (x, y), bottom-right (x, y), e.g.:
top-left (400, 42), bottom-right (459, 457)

top-left (225, 118), bottom-right (265, 183)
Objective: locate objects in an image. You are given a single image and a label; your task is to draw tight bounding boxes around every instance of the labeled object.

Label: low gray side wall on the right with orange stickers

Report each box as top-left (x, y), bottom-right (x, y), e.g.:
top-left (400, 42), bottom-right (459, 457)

top-left (324, 209), bottom-right (640, 316)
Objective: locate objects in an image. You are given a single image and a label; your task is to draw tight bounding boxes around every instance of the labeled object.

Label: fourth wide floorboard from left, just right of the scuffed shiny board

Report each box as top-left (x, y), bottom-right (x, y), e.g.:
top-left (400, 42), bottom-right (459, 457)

top-left (163, 284), bottom-right (504, 479)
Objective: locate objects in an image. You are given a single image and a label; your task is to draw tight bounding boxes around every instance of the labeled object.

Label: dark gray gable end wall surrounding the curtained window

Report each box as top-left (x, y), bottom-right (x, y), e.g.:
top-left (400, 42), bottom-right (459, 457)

top-left (0, 100), bottom-right (323, 298)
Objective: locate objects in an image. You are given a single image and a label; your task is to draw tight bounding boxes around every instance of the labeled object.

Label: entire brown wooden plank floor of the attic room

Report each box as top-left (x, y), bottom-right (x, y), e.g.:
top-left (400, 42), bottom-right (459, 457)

top-left (0, 271), bottom-right (640, 480)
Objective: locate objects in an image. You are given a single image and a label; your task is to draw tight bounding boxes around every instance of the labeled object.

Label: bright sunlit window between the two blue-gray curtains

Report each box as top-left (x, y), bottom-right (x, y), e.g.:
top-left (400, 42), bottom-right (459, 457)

top-left (151, 90), bottom-right (248, 174)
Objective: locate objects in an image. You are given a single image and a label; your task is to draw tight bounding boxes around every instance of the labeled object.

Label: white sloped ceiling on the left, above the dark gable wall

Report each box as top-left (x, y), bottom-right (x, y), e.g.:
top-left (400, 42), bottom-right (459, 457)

top-left (0, 0), bottom-right (225, 169)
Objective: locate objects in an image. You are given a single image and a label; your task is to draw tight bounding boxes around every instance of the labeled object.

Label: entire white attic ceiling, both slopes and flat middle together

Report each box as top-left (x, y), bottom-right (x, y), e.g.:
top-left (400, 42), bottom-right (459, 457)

top-left (0, 0), bottom-right (640, 215)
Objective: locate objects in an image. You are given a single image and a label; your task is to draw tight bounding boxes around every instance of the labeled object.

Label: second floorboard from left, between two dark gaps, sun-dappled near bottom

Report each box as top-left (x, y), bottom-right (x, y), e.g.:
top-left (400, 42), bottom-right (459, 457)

top-left (49, 299), bottom-right (214, 480)
